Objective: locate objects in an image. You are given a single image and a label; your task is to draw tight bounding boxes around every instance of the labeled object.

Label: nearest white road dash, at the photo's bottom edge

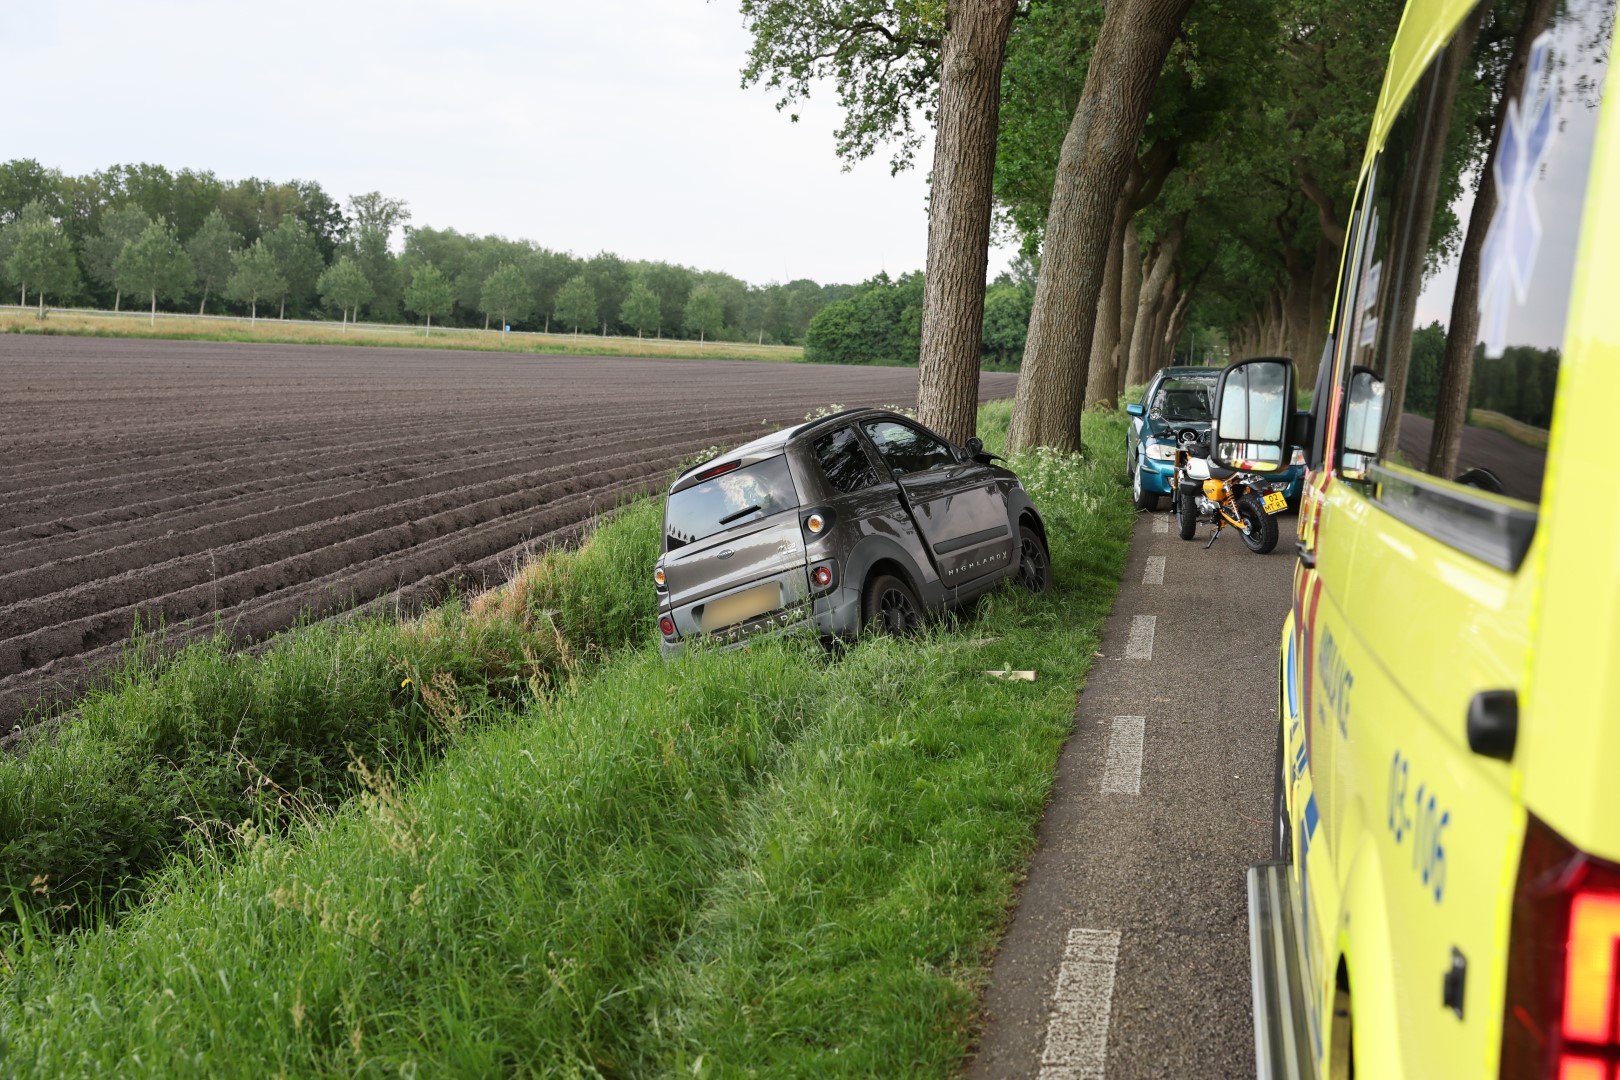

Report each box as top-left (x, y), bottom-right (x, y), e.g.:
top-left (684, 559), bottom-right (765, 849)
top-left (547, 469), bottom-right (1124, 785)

top-left (1040, 928), bottom-right (1119, 1080)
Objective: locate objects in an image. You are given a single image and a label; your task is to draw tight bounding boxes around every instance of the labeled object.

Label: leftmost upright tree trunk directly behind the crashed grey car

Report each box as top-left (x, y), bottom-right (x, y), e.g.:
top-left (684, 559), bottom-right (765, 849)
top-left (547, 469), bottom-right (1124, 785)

top-left (920, 0), bottom-right (1016, 444)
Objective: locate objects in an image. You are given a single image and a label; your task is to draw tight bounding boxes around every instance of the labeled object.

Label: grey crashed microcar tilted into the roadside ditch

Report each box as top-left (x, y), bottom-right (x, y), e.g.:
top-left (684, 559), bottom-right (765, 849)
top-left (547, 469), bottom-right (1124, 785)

top-left (653, 410), bottom-right (1051, 654)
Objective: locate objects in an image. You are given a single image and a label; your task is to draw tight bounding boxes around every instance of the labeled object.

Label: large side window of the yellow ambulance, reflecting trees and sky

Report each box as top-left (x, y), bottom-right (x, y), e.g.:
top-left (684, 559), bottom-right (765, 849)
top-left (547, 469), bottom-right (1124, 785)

top-left (1340, 0), bottom-right (1615, 565)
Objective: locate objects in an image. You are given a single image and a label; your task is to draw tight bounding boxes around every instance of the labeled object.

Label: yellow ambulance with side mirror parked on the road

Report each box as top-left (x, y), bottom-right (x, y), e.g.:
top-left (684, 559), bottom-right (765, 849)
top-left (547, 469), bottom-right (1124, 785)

top-left (1215, 0), bottom-right (1620, 1080)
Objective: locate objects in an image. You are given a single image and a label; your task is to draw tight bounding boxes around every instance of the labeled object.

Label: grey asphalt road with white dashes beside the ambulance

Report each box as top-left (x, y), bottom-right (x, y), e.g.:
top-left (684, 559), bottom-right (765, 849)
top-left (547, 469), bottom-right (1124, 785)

top-left (969, 501), bottom-right (1298, 1080)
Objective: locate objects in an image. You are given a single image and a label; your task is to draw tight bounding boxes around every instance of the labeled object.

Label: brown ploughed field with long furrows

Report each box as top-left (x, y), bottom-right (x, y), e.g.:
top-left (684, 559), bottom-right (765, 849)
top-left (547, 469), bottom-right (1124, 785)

top-left (0, 335), bottom-right (1014, 732)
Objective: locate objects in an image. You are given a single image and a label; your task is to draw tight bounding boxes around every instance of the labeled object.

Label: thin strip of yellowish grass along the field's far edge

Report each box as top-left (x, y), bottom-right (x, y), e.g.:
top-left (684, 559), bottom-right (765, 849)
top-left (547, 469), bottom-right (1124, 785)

top-left (0, 311), bottom-right (804, 361)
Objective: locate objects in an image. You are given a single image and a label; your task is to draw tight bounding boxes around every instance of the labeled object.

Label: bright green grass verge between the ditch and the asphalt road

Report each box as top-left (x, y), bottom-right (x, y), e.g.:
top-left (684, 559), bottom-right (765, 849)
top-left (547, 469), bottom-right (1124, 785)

top-left (0, 405), bottom-right (1132, 1077)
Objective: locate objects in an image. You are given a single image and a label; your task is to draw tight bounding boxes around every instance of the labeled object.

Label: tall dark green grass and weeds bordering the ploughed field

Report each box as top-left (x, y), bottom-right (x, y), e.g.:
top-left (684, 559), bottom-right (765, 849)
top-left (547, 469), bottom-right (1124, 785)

top-left (0, 500), bottom-right (661, 933)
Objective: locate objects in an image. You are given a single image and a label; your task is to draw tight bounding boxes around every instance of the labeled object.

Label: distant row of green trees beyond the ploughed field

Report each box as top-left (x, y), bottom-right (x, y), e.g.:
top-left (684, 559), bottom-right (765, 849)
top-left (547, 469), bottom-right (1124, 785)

top-left (0, 160), bottom-right (900, 345)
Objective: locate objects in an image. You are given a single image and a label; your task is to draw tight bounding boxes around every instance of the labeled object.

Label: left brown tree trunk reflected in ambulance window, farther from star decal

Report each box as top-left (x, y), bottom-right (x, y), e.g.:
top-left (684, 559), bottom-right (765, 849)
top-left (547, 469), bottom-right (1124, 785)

top-left (1379, 10), bottom-right (1484, 461)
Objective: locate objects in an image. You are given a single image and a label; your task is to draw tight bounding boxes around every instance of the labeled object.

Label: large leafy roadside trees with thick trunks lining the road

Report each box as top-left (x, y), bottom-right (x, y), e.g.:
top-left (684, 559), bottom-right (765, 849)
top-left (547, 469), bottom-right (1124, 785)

top-left (742, 0), bottom-right (1401, 449)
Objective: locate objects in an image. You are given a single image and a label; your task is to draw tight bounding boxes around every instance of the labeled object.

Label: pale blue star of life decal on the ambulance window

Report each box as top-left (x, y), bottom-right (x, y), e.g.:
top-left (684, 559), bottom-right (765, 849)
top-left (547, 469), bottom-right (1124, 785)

top-left (1479, 32), bottom-right (1554, 356)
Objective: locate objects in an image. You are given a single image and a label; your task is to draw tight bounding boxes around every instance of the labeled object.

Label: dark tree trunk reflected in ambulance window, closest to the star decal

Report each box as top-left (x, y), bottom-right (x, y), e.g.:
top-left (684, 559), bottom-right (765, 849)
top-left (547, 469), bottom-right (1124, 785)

top-left (1427, 0), bottom-right (1554, 478)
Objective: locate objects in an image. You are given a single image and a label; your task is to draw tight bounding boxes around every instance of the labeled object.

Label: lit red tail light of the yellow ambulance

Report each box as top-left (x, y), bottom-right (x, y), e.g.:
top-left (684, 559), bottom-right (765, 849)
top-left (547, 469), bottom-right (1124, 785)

top-left (1502, 818), bottom-right (1620, 1080)
